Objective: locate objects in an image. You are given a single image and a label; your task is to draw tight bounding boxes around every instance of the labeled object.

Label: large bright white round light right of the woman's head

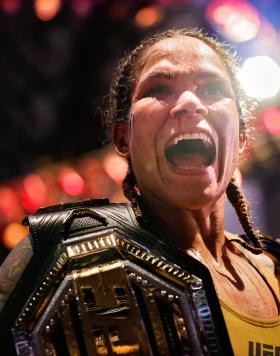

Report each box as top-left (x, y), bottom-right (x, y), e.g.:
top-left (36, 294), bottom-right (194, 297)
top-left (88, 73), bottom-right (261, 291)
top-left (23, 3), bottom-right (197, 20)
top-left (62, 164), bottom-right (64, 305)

top-left (238, 56), bottom-right (280, 99)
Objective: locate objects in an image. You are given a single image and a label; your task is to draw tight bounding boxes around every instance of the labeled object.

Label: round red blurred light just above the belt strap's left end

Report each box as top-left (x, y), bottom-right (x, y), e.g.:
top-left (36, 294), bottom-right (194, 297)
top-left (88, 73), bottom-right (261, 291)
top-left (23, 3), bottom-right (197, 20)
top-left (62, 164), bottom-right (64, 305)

top-left (22, 174), bottom-right (48, 213)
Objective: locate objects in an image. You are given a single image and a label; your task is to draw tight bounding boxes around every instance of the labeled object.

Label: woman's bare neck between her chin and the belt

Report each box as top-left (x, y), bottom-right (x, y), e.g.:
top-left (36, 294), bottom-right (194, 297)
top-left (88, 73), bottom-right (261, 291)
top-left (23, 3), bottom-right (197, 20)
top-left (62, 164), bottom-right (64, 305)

top-left (141, 193), bottom-right (225, 261)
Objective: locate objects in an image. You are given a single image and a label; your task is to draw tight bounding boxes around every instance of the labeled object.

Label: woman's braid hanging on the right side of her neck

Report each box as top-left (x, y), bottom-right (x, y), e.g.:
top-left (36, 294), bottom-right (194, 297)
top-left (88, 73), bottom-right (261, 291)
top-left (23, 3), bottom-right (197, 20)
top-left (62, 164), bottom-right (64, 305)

top-left (227, 178), bottom-right (263, 254)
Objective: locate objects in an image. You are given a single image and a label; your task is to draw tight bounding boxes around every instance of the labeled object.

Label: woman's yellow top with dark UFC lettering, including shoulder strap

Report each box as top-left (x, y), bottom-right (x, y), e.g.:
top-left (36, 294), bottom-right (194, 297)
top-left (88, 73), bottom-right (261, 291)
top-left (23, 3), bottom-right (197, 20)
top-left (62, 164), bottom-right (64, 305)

top-left (220, 249), bottom-right (280, 356)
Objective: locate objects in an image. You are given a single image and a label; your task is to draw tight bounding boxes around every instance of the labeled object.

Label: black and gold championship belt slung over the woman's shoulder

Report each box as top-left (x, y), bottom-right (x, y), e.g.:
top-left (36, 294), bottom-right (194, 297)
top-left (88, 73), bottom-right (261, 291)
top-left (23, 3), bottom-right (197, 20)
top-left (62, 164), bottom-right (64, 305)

top-left (0, 199), bottom-right (233, 356)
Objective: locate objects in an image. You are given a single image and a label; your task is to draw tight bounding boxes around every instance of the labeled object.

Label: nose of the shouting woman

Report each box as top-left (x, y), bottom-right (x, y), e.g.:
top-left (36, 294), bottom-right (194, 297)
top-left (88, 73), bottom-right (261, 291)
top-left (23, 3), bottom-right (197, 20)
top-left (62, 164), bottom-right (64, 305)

top-left (170, 91), bottom-right (208, 118)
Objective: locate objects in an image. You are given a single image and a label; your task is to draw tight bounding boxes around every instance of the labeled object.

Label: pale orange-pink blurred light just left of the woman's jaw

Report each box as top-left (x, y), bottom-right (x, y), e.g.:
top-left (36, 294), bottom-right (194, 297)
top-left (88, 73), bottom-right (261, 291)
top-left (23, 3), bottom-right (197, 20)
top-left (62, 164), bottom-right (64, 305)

top-left (103, 153), bottom-right (127, 184)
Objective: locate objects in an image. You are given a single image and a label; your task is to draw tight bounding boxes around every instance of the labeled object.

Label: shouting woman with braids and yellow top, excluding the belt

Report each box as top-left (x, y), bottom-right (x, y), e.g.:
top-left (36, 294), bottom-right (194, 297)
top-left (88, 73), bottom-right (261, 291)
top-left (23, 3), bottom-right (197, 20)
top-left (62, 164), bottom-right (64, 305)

top-left (0, 29), bottom-right (280, 355)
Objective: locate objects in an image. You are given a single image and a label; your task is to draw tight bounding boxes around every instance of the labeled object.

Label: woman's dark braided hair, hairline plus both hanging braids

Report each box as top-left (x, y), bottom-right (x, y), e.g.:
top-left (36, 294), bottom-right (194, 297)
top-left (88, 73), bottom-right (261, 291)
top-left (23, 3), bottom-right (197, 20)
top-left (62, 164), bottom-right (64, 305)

top-left (105, 28), bottom-right (262, 254)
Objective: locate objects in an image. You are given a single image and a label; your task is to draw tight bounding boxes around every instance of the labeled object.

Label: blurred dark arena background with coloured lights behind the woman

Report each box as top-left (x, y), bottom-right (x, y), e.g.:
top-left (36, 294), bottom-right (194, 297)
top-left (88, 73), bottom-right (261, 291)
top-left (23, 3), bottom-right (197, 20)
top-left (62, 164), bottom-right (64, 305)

top-left (0, 0), bottom-right (280, 262)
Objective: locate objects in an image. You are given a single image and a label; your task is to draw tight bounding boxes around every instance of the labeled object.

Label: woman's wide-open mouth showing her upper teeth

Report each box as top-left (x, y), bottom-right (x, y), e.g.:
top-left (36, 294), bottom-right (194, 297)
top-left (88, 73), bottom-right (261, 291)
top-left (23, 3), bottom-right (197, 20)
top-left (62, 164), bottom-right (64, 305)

top-left (165, 133), bottom-right (216, 169)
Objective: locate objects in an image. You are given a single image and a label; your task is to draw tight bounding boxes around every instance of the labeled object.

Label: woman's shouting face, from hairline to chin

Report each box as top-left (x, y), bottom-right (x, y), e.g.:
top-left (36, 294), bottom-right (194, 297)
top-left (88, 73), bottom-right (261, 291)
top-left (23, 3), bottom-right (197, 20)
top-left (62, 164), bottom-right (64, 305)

top-left (115, 36), bottom-right (242, 210)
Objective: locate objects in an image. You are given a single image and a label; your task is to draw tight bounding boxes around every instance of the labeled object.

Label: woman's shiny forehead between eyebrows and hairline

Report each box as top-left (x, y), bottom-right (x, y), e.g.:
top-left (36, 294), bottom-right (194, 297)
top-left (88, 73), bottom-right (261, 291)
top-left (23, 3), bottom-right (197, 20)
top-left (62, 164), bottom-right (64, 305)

top-left (138, 36), bottom-right (229, 78)
